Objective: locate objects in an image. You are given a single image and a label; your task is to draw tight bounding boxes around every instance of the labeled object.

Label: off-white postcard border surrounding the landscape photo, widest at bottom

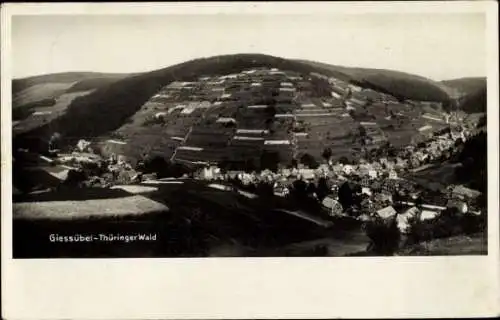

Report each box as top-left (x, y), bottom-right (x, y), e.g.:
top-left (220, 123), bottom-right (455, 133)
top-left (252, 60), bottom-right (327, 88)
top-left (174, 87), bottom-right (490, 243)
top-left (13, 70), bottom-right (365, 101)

top-left (1, 1), bottom-right (500, 319)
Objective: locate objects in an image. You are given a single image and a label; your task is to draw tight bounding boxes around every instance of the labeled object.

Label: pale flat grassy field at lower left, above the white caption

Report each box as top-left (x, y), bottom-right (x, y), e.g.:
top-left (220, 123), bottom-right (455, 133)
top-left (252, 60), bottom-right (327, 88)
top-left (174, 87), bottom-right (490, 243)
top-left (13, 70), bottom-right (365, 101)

top-left (13, 195), bottom-right (168, 220)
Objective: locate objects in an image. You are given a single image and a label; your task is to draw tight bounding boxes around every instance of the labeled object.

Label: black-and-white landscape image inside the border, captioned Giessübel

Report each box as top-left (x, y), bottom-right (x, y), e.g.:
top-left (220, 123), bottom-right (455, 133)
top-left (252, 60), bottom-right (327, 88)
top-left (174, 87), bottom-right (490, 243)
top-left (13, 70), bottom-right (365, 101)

top-left (6, 6), bottom-right (488, 258)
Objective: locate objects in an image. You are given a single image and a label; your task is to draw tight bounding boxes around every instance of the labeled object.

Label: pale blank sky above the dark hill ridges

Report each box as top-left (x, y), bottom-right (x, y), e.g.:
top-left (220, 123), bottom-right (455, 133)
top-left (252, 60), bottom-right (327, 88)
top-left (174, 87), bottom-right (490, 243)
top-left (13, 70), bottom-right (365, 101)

top-left (12, 13), bottom-right (486, 80)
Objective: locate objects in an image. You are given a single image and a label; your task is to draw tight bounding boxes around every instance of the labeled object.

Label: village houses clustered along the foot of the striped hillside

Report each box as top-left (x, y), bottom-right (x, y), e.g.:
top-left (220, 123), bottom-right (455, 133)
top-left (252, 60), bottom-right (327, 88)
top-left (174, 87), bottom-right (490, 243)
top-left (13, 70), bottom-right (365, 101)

top-left (193, 119), bottom-right (480, 232)
